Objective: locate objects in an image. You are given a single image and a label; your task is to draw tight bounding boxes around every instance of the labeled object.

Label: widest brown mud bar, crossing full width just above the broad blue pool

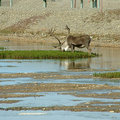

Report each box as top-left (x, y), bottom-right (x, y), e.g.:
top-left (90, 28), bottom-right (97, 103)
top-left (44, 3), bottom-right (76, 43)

top-left (0, 83), bottom-right (120, 93)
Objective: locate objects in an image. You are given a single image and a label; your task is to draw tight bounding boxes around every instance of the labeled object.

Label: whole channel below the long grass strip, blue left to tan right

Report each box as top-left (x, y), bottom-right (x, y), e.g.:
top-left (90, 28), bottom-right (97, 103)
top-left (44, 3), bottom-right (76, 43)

top-left (0, 47), bottom-right (120, 73)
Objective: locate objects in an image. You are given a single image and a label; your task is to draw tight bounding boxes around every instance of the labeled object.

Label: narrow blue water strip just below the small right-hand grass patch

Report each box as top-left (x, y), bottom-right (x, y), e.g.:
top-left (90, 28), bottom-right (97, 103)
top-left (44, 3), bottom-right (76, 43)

top-left (0, 77), bottom-right (120, 86)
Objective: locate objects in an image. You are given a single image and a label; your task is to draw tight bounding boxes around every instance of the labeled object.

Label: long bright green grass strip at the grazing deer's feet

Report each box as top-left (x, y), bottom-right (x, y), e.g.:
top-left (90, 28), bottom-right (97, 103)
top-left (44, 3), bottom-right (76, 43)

top-left (0, 50), bottom-right (97, 59)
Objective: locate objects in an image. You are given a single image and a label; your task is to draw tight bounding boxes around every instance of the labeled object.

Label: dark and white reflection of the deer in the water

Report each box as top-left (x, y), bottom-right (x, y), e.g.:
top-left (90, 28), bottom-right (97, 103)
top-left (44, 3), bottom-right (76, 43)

top-left (60, 58), bottom-right (91, 70)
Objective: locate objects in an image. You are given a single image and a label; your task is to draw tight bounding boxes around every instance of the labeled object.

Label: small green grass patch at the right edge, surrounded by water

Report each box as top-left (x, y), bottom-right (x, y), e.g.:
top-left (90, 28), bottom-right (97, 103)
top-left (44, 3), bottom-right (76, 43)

top-left (93, 72), bottom-right (120, 78)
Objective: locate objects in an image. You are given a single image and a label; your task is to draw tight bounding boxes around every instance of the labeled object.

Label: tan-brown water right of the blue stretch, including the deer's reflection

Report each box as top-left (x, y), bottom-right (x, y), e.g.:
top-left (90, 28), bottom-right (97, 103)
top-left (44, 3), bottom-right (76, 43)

top-left (60, 47), bottom-right (120, 71)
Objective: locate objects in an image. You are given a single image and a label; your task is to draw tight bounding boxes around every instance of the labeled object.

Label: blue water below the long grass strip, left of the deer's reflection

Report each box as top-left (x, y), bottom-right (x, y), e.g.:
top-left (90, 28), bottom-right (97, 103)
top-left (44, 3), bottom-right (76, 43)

top-left (0, 59), bottom-right (60, 73)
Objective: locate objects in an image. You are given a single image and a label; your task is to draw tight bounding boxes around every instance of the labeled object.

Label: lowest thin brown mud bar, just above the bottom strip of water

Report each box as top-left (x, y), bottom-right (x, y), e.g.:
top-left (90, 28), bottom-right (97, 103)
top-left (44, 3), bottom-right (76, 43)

top-left (0, 104), bottom-right (120, 113)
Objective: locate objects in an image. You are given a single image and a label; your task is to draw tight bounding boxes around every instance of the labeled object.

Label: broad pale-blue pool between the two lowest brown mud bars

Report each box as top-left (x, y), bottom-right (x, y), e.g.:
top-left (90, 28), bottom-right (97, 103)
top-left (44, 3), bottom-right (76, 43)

top-left (0, 90), bottom-right (120, 108)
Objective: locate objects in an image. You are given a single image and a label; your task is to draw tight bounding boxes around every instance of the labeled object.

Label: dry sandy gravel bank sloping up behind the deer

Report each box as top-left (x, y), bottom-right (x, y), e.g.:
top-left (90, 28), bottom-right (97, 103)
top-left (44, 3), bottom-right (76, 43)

top-left (0, 0), bottom-right (120, 49)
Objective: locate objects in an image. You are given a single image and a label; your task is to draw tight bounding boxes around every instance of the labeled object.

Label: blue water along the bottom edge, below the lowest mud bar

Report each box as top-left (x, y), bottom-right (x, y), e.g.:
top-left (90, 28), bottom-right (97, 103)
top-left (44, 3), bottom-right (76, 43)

top-left (0, 111), bottom-right (120, 120)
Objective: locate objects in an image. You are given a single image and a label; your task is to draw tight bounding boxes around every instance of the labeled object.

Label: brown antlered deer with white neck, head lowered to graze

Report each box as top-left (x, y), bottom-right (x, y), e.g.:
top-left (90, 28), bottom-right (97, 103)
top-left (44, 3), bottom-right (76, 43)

top-left (49, 25), bottom-right (92, 54)
